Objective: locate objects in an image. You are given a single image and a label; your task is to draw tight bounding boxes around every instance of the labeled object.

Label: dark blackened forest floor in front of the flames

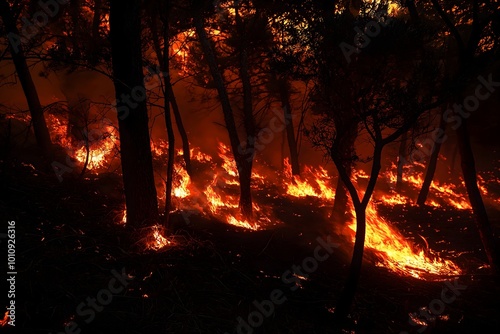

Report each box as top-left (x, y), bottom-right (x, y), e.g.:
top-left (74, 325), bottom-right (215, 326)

top-left (0, 151), bottom-right (500, 334)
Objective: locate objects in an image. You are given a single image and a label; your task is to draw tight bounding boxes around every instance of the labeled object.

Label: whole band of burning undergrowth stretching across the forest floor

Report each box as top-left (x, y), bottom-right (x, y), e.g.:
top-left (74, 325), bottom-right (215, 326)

top-left (6, 111), bottom-right (499, 280)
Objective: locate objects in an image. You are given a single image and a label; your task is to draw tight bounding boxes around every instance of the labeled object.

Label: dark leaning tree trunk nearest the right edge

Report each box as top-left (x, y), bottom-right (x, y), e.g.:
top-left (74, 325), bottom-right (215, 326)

top-left (457, 119), bottom-right (500, 272)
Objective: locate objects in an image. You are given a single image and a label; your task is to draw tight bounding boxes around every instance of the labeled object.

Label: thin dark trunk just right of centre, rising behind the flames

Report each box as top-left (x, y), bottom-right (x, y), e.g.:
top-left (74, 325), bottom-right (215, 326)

top-left (278, 79), bottom-right (300, 175)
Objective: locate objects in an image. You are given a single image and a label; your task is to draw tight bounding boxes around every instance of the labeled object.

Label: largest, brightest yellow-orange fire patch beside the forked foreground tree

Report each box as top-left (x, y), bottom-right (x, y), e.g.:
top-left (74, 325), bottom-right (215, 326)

top-left (348, 204), bottom-right (461, 279)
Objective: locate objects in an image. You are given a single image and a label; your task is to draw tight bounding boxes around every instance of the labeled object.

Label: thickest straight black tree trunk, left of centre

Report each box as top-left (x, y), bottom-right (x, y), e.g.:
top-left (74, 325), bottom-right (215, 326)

top-left (110, 0), bottom-right (158, 227)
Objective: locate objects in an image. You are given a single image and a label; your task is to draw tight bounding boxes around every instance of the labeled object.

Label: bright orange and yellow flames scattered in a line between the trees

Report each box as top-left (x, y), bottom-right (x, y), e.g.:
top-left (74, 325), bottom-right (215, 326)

top-left (38, 109), bottom-right (468, 279)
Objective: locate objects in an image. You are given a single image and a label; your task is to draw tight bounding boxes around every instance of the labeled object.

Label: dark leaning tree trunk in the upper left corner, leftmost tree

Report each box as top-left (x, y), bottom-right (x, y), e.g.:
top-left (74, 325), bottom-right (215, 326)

top-left (0, 0), bottom-right (52, 154)
